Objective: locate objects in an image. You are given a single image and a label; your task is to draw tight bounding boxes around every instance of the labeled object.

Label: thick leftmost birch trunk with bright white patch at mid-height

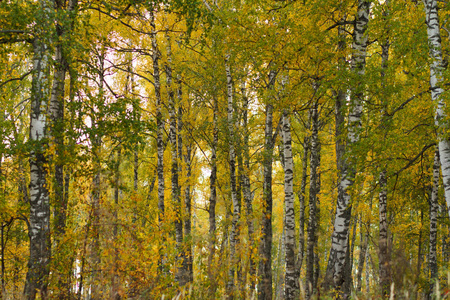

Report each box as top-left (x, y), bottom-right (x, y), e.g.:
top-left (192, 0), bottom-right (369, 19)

top-left (24, 0), bottom-right (54, 299)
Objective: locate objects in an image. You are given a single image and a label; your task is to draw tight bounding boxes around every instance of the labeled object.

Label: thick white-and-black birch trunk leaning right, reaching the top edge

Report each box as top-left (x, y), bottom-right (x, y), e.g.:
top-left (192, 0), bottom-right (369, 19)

top-left (324, 0), bottom-right (370, 290)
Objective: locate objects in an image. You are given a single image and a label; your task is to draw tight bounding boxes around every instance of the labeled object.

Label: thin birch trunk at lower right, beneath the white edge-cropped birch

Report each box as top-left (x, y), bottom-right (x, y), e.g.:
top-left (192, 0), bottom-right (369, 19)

top-left (429, 149), bottom-right (439, 298)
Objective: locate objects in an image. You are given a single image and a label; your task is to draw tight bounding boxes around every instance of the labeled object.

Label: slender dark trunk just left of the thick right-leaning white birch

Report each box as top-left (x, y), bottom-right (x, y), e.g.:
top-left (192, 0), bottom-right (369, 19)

top-left (306, 101), bottom-right (320, 299)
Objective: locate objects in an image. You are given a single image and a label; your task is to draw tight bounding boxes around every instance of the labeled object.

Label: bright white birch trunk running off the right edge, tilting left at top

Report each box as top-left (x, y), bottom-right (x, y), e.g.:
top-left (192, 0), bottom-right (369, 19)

top-left (424, 0), bottom-right (450, 220)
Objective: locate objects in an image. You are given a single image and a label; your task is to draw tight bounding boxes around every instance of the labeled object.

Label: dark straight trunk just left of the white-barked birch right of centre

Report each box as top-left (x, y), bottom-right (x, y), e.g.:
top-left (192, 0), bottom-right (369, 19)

top-left (258, 71), bottom-right (276, 300)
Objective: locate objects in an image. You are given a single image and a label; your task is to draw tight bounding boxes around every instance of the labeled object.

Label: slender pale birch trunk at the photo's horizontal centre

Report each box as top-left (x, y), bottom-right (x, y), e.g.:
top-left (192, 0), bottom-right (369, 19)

top-left (225, 56), bottom-right (241, 299)
